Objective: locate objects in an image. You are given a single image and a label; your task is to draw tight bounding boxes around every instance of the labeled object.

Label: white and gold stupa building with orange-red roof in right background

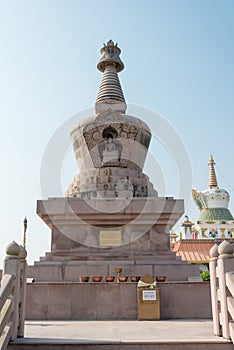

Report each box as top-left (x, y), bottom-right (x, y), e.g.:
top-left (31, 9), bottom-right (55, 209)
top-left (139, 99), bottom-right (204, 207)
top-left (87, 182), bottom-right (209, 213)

top-left (172, 155), bottom-right (234, 264)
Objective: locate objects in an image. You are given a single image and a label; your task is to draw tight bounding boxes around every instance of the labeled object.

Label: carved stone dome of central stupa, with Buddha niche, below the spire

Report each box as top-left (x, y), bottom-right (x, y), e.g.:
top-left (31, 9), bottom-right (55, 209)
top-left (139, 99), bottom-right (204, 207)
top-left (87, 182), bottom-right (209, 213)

top-left (71, 108), bottom-right (151, 171)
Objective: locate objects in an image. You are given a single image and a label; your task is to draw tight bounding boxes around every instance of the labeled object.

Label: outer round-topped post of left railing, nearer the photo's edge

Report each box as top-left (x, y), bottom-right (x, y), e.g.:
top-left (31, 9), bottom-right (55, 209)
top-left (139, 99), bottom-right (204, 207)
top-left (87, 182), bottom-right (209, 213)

top-left (3, 241), bottom-right (20, 340)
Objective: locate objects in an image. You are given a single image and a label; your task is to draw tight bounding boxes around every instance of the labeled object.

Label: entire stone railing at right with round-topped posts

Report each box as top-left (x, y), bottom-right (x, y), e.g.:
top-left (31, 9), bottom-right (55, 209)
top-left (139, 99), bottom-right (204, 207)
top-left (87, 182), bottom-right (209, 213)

top-left (210, 241), bottom-right (234, 343)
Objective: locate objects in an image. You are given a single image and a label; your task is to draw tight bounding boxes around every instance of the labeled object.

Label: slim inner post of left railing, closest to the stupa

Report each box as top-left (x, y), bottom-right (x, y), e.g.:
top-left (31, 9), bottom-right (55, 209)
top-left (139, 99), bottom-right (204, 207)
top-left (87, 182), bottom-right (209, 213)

top-left (17, 245), bottom-right (27, 338)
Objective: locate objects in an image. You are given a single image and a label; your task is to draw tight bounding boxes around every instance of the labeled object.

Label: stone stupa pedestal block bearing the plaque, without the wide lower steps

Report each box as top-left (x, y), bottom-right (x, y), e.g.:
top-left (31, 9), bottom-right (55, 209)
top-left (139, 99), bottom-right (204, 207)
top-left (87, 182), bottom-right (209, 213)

top-left (37, 197), bottom-right (184, 261)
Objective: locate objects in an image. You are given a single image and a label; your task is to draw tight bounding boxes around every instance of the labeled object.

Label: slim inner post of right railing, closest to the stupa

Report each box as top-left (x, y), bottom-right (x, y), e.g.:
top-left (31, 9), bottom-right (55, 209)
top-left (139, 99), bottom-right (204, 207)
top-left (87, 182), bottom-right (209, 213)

top-left (209, 244), bottom-right (222, 336)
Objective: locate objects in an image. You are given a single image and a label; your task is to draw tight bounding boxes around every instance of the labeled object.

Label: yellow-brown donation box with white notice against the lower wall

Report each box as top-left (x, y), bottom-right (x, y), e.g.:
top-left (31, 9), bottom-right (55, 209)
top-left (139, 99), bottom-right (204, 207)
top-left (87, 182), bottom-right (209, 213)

top-left (137, 275), bottom-right (160, 320)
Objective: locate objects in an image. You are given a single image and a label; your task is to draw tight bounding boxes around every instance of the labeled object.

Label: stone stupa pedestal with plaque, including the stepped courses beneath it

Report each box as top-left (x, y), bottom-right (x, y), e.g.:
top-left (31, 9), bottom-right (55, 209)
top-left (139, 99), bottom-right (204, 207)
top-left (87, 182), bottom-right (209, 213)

top-left (28, 197), bottom-right (199, 282)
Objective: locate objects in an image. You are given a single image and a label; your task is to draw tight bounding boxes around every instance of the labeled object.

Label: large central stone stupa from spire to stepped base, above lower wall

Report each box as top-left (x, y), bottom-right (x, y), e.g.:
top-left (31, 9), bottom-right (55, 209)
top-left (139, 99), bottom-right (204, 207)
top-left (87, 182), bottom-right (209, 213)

top-left (30, 40), bottom-right (199, 281)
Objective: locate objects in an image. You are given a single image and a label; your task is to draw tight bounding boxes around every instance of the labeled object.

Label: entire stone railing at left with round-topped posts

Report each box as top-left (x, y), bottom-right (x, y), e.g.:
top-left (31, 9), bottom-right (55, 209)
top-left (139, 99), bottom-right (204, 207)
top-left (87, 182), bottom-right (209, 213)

top-left (0, 241), bottom-right (27, 350)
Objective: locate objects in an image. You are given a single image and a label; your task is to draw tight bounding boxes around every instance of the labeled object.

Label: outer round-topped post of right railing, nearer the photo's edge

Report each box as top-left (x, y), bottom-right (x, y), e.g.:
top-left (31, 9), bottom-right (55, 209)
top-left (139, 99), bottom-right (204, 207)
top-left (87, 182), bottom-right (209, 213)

top-left (217, 241), bottom-right (234, 339)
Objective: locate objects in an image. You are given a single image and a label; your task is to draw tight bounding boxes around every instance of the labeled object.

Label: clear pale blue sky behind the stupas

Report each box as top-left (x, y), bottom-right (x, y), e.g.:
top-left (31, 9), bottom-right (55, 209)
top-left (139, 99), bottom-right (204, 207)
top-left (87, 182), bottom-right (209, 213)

top-left (0, 0), bottom-right (234, 266)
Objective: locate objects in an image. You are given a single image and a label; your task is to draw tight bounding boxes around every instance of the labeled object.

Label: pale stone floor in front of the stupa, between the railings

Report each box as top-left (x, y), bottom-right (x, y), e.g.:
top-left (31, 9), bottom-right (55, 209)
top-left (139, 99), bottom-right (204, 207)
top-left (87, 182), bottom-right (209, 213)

top-left (7, 320), bottom-right (234, 350)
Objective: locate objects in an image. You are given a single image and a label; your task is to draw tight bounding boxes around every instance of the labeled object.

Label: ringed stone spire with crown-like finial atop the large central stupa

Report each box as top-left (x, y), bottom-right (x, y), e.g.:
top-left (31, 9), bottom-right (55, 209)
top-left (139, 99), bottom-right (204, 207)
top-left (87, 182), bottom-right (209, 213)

top-left (95, 40), bottom-right (126, 114)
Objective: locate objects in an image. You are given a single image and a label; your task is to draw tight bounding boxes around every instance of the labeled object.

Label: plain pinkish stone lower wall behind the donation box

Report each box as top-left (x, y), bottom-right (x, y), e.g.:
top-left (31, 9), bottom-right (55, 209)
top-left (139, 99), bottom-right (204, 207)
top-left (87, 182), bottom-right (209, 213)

top-left (26, 282), bottom-right (212, 320)
